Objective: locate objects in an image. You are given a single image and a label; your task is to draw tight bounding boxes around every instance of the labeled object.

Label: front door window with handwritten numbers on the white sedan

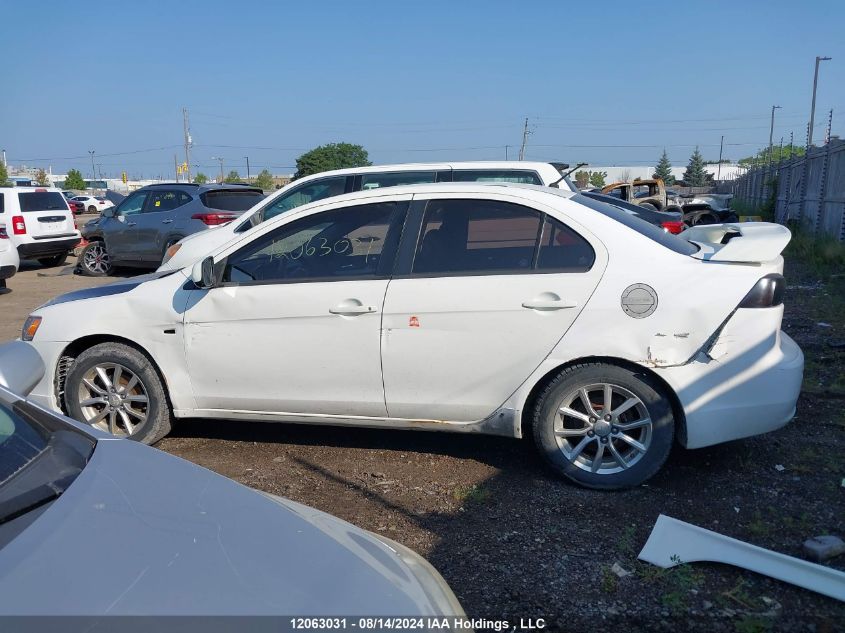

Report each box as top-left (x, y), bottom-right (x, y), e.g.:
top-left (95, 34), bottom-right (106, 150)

top-left (223, 202), bottom-right (398, 284)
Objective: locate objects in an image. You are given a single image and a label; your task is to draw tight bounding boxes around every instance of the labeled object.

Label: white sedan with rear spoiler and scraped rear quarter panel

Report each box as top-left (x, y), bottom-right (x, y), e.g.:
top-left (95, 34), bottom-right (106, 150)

top-left (22, 183), bottom-right (804, 488)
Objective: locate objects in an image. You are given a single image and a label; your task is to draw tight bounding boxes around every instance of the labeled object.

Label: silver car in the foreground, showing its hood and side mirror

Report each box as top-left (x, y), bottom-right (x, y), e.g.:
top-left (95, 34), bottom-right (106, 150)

top-left (0, 342), bottom-right (464, 616)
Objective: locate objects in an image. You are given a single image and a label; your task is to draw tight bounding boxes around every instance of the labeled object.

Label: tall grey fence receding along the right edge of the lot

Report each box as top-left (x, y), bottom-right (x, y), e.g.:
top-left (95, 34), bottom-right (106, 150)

top-left (719, 138), bottom-right (845, 241)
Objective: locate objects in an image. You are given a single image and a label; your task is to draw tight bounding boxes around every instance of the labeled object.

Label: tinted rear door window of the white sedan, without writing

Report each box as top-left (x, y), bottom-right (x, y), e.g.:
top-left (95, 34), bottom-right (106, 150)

top-left (412, 200), bottom-right (595, 275)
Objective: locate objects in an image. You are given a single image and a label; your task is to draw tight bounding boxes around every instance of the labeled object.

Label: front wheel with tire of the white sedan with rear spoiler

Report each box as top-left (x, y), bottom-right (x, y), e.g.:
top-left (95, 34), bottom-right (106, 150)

top-left (65, 343), bottom-right (170, 444)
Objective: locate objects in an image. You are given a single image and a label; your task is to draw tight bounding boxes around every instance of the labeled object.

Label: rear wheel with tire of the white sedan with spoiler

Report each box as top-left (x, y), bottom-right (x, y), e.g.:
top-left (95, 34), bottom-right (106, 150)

top-left (534, 363), bottom-right (674, 490)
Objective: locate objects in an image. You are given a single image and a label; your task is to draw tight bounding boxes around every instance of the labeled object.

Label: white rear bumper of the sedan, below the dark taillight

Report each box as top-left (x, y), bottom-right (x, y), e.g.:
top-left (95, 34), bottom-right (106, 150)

top-left (656, 331), bottom-right (804, 448)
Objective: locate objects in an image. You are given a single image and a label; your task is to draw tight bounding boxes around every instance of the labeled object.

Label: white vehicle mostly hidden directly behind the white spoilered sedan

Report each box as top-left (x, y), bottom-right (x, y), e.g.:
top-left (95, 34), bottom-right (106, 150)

top-left (160, 161), bottom-right (577, 270)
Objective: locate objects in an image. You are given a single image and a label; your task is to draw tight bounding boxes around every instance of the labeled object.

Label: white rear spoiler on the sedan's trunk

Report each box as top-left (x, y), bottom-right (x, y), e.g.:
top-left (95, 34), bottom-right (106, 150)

top-left (679, 222), bottom-right (792, 264)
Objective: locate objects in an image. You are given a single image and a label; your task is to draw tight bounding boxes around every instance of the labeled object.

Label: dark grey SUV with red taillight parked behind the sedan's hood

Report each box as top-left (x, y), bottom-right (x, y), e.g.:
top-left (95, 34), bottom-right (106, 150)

top-left (79, 183), bottom-right (264, 277)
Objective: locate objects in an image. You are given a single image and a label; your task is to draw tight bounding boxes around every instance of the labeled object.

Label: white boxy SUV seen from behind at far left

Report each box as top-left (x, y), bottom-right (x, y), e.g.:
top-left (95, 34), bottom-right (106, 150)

top-left (0, 187), bottom-right (79, 266)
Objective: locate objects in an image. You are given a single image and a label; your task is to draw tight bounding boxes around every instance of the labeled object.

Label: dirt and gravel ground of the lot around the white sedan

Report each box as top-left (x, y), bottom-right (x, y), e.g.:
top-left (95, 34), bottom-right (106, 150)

top-left (0, 251), bottom-right (845, 632)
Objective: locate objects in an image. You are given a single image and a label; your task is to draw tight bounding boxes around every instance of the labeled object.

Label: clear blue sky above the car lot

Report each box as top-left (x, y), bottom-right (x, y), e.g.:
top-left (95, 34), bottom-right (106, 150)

top-left (0, 0), bottom-right (845, 177)
